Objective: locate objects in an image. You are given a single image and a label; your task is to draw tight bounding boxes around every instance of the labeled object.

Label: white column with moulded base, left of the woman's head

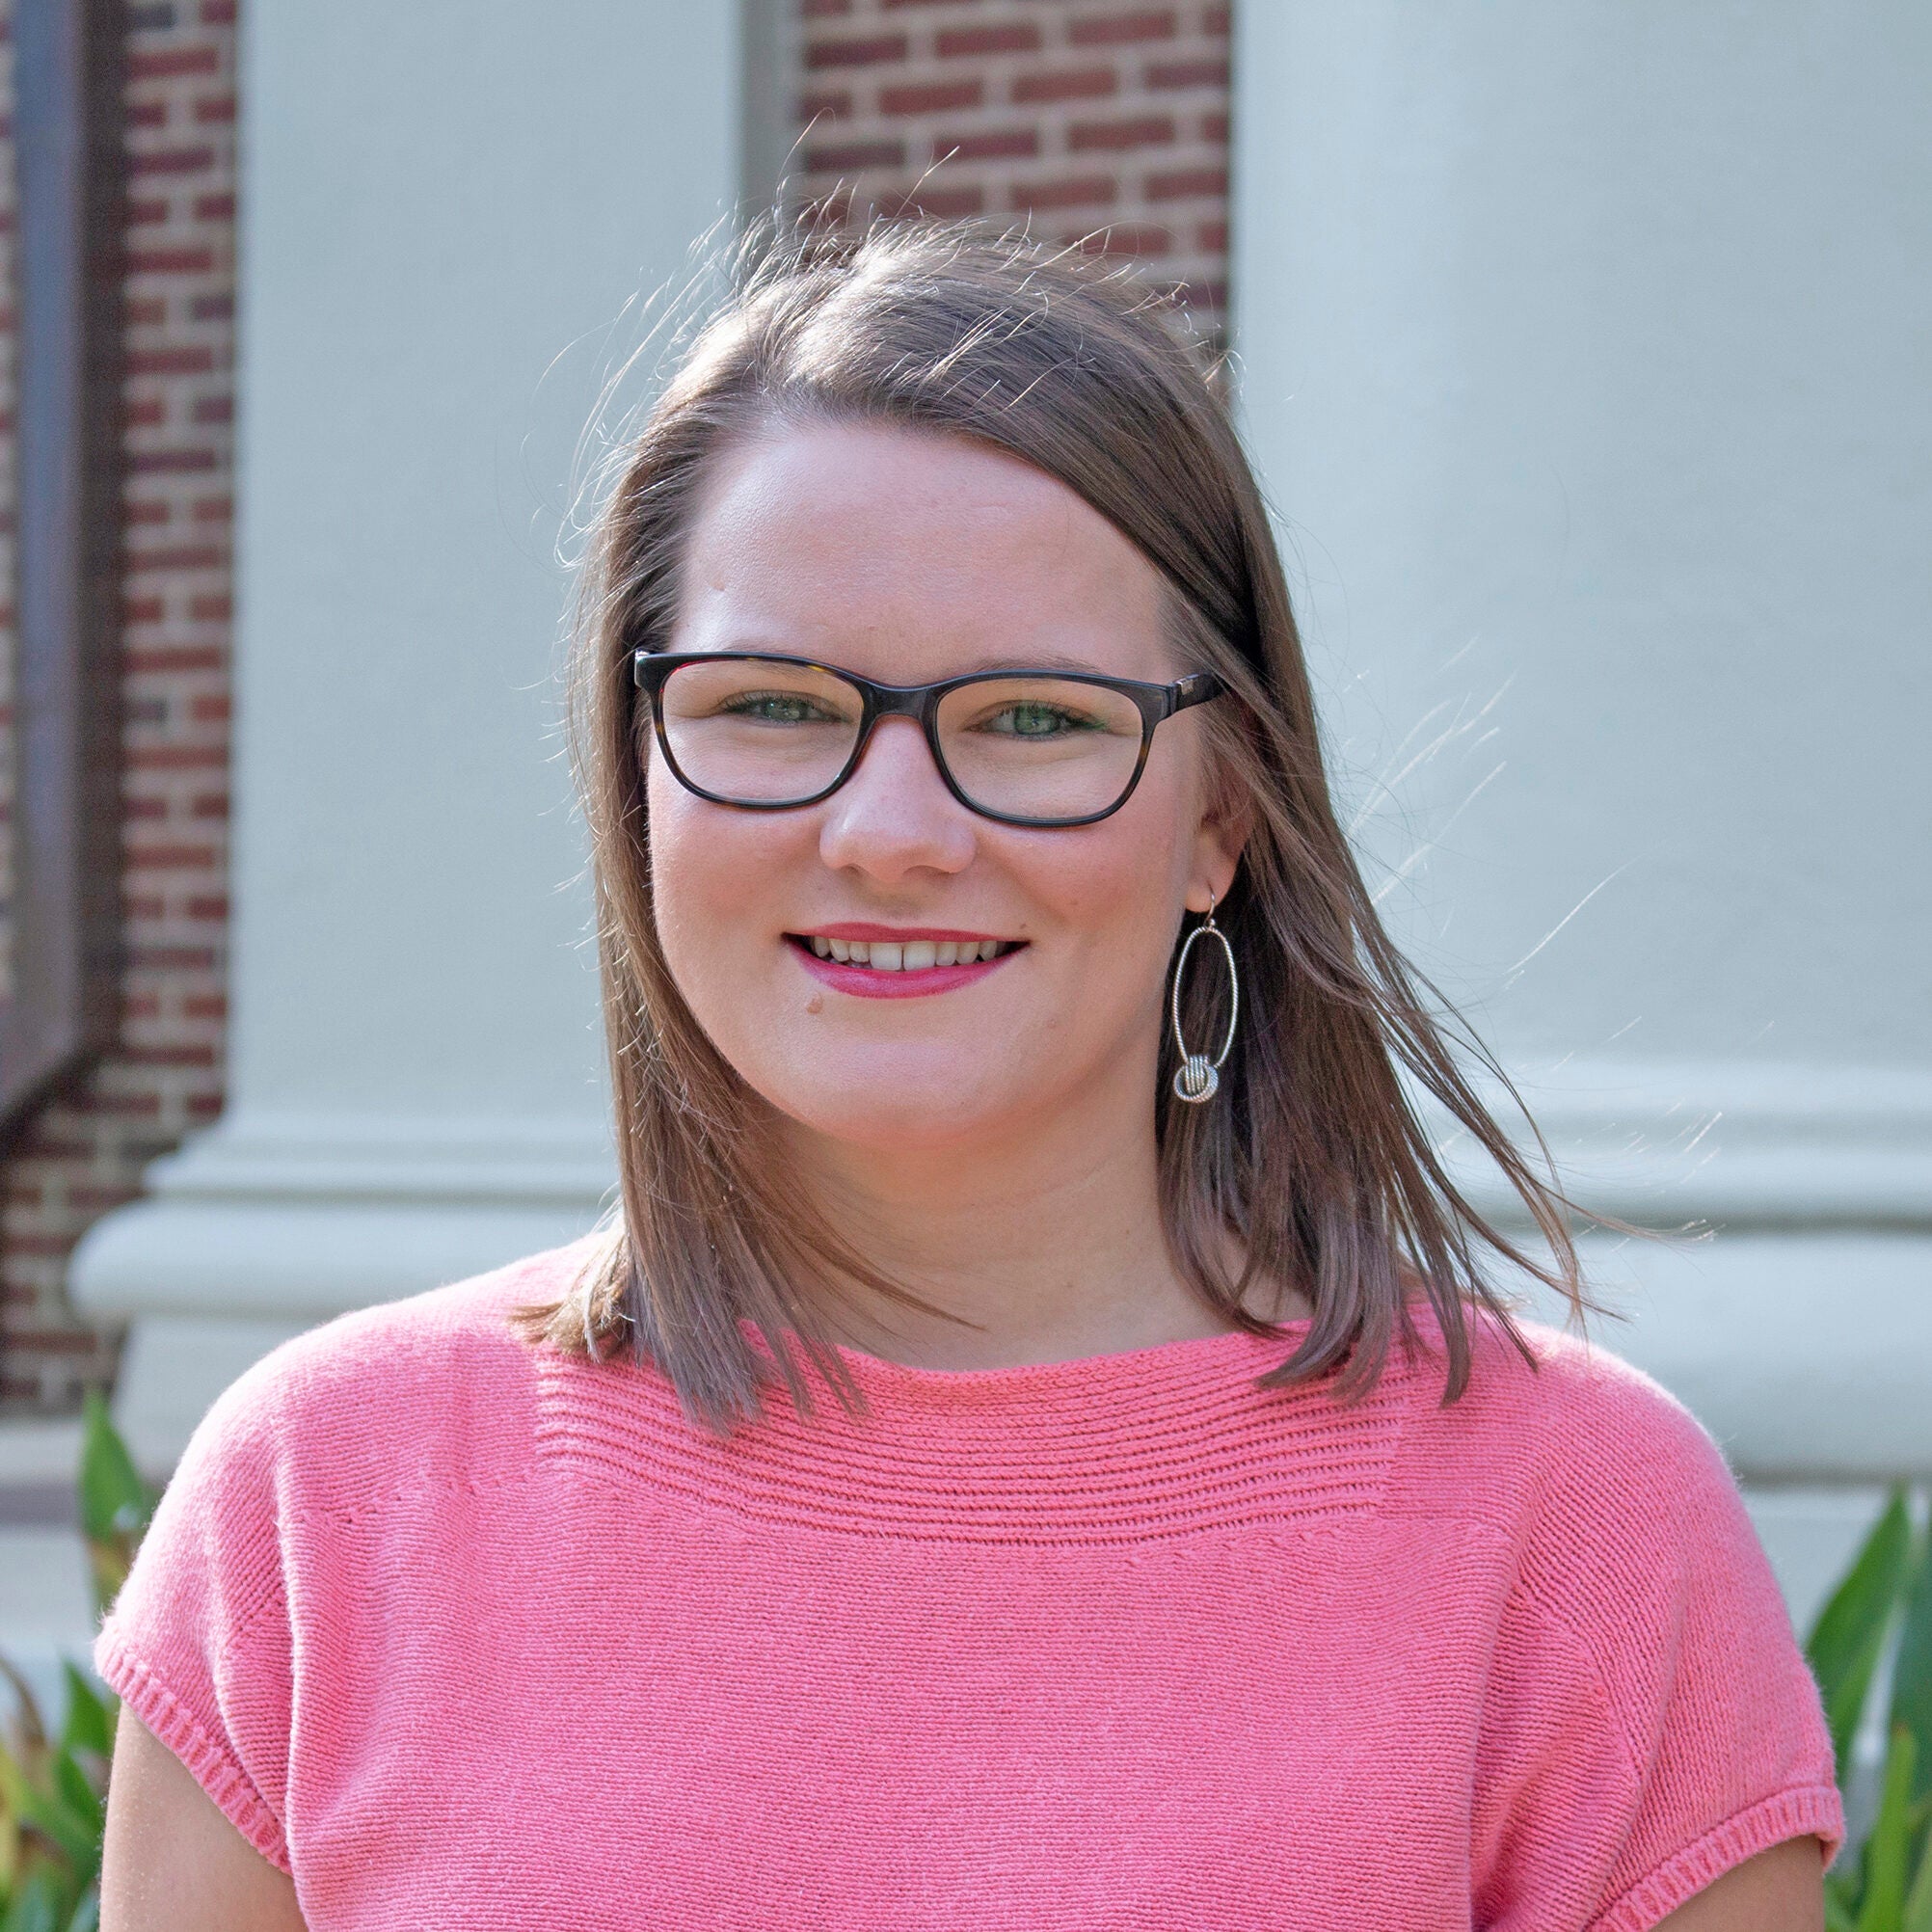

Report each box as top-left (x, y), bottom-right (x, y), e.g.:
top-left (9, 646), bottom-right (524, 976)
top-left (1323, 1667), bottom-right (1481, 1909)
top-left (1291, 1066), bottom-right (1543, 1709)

top-left (73, 0), bottom-right (740, 1466)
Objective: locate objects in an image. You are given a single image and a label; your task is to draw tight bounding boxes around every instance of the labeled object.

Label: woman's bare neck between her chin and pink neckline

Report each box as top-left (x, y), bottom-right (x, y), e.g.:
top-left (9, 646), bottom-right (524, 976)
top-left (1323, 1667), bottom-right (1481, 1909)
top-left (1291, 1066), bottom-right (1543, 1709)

top-left (787, 1093), bottom-right (1297, 1370)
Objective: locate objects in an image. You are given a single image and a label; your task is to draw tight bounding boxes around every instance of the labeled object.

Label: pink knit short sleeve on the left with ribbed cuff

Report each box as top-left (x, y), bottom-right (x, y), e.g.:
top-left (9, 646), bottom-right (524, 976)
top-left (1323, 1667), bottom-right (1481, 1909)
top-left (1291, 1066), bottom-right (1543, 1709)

top-left (93, 1356), bottom-right (292, 1874)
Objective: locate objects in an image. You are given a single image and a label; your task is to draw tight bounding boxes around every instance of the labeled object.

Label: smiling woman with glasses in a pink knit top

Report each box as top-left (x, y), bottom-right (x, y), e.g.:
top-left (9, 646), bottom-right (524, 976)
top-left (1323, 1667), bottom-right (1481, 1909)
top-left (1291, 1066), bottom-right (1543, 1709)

top-left (96, 228), bottom-right (1843, 1932)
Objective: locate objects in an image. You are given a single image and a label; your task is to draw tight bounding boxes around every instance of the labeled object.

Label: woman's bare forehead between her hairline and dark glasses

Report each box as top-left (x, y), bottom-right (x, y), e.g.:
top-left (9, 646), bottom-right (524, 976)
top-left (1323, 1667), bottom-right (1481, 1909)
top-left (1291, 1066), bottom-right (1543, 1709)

top-left (672, 423), bottom-right (1174, 682)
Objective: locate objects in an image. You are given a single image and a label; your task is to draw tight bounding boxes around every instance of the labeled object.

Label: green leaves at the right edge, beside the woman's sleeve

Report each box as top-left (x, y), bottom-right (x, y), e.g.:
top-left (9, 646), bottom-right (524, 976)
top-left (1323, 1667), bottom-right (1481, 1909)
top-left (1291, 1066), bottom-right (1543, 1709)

top-left (1805, 1488), bottom-right (1932, 1932)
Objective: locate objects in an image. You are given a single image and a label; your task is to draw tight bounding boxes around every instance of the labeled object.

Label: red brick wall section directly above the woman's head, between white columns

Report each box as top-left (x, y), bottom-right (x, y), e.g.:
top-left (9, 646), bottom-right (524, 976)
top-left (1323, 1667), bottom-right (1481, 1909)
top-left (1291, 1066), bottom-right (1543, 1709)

top-left (792, 0), bottom-right (1229, 331)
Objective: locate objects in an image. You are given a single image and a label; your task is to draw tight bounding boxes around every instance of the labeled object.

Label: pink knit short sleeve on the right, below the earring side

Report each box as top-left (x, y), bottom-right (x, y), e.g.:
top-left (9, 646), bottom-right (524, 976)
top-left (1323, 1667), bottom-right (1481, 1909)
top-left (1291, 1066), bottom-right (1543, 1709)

top-left (1472, 1358), bottom-right (1845, 1932)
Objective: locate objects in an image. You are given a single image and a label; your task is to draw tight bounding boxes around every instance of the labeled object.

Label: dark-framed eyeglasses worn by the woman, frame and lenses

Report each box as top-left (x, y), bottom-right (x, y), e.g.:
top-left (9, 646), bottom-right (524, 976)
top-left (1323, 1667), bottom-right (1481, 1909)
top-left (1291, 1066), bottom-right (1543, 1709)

top-left (631, 651), bottom-right (1227, 825)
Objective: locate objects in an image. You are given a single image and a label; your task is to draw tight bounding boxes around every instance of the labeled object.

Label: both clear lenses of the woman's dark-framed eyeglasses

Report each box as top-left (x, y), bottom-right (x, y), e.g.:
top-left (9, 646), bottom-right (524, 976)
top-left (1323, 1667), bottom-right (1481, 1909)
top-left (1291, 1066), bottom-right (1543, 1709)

top-left (658, 658), bottom-right (1143, 819)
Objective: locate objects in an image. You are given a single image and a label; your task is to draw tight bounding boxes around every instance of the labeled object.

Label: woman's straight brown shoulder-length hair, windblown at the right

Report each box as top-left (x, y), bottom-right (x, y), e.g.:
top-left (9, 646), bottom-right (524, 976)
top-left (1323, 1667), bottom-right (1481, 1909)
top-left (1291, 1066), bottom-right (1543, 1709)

top-left (518, 224), bottom-right (1584, 1432)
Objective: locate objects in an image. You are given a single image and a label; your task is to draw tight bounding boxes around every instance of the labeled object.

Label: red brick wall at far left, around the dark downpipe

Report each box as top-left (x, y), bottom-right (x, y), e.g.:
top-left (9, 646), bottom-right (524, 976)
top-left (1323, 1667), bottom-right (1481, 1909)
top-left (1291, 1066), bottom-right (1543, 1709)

top-left (0, 0), bottom-right (235, 1412)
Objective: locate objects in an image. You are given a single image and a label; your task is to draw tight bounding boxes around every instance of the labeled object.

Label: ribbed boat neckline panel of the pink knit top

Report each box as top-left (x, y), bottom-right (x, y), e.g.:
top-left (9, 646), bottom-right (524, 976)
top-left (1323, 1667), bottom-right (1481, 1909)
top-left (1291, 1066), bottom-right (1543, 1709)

top-left (537, 1324), bottom-right (1410, 1543)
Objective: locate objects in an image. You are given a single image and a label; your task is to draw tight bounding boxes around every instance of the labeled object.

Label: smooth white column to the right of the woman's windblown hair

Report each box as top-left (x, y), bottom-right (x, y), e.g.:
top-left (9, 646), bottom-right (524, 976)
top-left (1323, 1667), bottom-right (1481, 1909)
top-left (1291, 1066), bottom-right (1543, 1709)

top-left (1233, 0), bottom-right (1932, 1480)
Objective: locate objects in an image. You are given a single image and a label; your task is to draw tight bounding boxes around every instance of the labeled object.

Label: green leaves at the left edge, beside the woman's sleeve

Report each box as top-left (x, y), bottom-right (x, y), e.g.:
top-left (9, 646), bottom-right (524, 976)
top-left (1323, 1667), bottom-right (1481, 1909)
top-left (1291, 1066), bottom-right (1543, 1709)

top-left (0, 1389), bottom-right (156, 1932)
